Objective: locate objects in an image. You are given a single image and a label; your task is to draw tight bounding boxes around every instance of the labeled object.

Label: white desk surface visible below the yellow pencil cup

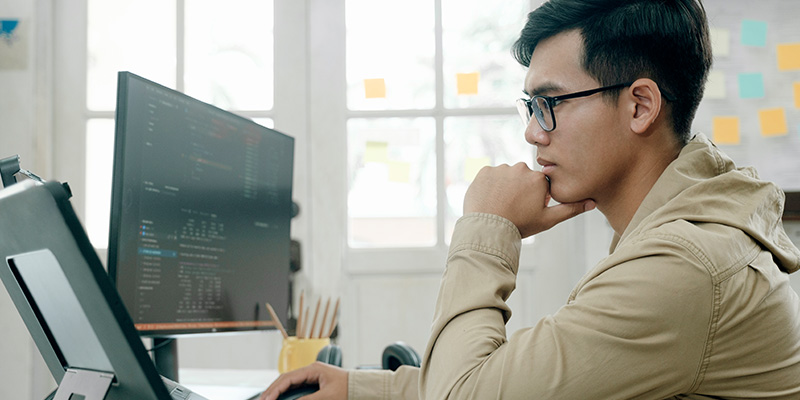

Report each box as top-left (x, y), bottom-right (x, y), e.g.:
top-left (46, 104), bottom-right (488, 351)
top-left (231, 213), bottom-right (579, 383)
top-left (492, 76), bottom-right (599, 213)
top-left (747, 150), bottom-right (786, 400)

top-left (178, 368), bottom-right (279, 400)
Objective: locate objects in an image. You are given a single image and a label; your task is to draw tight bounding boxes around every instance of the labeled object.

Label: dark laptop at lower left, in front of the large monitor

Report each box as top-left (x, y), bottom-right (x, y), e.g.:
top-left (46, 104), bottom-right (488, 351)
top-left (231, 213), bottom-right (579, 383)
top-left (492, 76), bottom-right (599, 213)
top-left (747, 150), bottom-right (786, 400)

top-left (0, 180), bottom-right (206, 400)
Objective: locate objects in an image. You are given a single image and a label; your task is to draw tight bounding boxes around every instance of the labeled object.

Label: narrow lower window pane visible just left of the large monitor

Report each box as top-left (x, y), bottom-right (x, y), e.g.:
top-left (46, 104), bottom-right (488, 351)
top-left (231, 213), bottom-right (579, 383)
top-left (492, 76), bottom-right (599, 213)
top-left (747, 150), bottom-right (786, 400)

top-left (84, 119), bottom-right (114, 248)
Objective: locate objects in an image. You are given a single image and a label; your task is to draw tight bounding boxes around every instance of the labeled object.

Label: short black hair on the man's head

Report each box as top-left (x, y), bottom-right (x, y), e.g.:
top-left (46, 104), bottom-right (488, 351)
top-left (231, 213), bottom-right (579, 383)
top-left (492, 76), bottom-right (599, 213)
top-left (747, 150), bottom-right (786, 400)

top-left (512, 0), bottom-right (712, 145)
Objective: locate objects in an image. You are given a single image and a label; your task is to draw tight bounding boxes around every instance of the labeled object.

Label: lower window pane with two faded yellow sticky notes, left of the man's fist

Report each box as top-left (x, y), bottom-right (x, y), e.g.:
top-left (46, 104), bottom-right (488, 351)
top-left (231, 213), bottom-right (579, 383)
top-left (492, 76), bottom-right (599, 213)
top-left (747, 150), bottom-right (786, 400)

top-left (347, 118), bottom-right (436, 247)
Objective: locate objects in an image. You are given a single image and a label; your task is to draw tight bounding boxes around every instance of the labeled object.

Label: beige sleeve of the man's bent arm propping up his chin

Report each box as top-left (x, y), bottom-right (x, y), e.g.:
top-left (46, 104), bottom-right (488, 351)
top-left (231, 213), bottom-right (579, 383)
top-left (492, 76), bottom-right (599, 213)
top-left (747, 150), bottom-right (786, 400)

top-left (420, 214), bottom-right (713, 399)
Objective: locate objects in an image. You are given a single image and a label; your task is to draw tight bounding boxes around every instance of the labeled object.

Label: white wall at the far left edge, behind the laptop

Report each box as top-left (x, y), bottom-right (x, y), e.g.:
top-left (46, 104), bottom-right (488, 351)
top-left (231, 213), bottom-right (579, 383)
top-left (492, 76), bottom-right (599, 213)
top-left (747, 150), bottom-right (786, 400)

top-left (0, 0), bottom-right (55, 399)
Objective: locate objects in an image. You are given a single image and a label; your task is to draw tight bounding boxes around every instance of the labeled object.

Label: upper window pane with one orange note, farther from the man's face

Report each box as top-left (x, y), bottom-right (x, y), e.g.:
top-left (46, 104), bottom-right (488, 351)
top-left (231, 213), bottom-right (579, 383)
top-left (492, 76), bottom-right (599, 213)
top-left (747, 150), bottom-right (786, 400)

top-left (346, 0), bottom-right (436, 110)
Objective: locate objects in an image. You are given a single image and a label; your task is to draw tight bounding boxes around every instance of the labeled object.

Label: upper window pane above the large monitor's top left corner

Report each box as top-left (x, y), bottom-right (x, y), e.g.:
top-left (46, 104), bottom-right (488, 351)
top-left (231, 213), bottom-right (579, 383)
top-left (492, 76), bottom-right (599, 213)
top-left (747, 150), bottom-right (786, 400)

top-left (86, 0), bottom-right (176, 111)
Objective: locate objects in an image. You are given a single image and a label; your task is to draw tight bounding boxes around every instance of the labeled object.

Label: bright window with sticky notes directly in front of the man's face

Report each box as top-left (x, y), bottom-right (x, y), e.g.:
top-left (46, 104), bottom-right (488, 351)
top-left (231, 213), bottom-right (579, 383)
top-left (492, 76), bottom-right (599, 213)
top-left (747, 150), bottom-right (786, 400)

top-left (345, 0), bottom-right (533, 249)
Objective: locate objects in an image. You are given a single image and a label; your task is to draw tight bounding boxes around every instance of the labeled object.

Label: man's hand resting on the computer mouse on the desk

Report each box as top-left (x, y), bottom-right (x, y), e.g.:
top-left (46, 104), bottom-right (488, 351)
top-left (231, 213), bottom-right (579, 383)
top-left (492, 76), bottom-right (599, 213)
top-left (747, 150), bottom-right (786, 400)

top-left (259, 362), bottom-right (348, 400)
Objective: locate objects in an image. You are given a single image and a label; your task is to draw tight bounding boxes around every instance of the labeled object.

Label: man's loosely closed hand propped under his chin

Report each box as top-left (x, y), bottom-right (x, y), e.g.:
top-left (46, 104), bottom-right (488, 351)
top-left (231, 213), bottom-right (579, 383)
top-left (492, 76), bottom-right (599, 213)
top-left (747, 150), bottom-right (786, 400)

top-left (464, 163), bottom-right (595, 238)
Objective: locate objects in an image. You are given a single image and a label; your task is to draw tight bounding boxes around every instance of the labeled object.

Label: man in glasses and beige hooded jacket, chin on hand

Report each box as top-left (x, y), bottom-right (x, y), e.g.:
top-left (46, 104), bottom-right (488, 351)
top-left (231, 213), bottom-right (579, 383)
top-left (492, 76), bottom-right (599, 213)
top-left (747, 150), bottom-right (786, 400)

top-left (263, 0), bottom-right (800, 399)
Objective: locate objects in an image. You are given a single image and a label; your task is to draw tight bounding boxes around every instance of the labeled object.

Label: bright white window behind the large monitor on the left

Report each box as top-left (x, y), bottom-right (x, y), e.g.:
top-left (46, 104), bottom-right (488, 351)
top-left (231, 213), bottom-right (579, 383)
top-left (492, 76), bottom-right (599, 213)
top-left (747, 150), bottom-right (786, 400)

top-left (85, 0), bottom-right (274, 248)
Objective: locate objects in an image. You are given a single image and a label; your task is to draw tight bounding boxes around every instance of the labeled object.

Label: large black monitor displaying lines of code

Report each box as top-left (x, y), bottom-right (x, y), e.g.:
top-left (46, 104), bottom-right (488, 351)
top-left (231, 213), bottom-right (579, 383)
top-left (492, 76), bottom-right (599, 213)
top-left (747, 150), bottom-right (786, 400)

top-left (108, 72), bottom-right (294, 337)
